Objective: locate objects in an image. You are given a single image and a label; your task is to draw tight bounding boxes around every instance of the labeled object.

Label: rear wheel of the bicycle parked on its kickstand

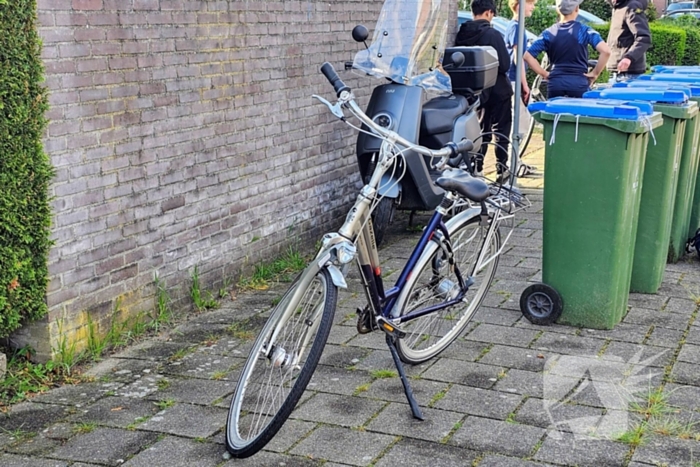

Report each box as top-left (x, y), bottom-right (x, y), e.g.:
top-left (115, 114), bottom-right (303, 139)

top-left (396, 214), bottom-right (501, 364)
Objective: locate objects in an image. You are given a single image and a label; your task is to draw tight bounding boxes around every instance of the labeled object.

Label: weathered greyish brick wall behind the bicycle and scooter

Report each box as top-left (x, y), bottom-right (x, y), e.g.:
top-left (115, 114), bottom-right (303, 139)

top-left (15, 0), bottom-right (456, 362)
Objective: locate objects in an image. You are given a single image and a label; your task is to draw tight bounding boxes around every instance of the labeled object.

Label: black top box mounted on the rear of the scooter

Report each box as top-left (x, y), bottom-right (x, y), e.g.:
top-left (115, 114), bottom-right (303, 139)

top-left (443, 46), bottom-right (498, 94)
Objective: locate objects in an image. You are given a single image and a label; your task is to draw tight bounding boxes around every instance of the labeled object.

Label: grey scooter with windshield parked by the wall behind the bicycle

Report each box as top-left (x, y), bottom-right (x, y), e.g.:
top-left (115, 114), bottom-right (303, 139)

top-left (345, 18), bottom-right (498, 244)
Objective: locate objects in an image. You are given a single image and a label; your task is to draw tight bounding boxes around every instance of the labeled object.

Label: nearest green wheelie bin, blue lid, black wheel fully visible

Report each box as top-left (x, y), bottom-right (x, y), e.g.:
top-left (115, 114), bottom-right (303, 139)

top-left (520, 99), bottom-right (663, 329)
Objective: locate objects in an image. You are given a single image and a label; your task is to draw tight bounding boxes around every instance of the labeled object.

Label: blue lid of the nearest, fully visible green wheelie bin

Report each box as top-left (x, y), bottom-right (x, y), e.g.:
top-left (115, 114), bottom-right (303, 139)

top-left (527, 97), bottom-right (654, 120)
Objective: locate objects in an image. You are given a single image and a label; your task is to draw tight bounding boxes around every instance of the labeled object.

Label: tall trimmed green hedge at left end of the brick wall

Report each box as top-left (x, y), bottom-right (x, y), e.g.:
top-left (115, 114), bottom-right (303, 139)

top-left (0, 0), bottom-right (53, 337)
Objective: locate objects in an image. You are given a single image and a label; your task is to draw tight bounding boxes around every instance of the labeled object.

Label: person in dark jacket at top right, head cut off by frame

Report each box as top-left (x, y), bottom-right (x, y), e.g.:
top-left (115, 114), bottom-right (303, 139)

top-left (608, 0), bottom-right (651, 78)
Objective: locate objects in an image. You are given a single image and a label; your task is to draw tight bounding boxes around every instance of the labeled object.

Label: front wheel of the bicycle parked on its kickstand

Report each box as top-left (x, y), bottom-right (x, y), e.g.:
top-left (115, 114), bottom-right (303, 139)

top-left (226, 268), bottom-right (338, 458)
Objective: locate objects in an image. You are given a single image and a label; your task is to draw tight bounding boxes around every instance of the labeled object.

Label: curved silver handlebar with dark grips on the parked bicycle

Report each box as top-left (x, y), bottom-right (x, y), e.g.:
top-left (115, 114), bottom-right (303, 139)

top-left (321, 62), bottom-right (474, 169)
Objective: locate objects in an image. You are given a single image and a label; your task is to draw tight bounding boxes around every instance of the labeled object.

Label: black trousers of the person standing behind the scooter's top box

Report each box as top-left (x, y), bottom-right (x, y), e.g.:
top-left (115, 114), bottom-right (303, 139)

top-left (475, 97), bottom-right (513, 173)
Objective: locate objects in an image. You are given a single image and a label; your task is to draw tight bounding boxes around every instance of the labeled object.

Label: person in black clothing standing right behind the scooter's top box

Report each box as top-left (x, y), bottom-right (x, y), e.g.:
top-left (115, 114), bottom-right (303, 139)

top-left (455, 0), bottom-right (513, 182)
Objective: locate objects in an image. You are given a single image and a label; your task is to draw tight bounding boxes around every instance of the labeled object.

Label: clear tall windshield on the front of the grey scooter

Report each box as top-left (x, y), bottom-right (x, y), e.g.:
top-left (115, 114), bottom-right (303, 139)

top-left (353, 0), bottom-right (452, 93)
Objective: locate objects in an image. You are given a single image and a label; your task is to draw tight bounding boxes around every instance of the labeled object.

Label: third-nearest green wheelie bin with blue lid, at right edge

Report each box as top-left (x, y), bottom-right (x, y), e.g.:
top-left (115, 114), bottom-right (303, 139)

top-left (636, 73), bottom-right (700, 263)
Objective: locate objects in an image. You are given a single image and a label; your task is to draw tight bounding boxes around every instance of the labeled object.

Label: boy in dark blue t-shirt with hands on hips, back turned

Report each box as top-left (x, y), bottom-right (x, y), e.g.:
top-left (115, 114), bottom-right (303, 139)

top-left (523, 0), bottom-right (610, 99)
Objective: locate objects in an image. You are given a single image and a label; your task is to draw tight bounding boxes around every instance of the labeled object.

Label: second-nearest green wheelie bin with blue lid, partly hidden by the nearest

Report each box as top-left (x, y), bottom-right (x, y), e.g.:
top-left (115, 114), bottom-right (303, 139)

top-left (584, 87), bottom-right (698, 294)
